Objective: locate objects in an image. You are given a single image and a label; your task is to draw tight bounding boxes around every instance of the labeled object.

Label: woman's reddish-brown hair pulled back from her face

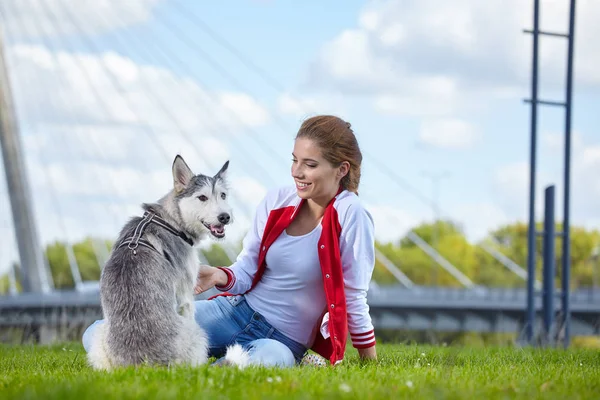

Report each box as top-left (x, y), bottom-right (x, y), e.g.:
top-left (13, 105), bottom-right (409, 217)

top-left (296, 115), bottom-right (362, 194)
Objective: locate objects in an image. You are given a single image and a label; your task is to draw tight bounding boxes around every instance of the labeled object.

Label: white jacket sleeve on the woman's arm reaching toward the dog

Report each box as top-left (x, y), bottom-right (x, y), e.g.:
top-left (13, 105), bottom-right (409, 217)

top-left (215, 188), bottom-right (270, 294)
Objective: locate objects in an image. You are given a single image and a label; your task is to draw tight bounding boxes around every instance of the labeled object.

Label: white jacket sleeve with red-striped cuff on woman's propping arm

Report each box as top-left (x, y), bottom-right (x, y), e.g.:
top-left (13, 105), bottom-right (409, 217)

top-left (340, 202), bottom-right (375, 349)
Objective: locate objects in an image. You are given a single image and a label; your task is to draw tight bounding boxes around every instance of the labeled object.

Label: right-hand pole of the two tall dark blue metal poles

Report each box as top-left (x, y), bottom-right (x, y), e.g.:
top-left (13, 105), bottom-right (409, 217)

top-left (562, 0), bottom-right (575, 348)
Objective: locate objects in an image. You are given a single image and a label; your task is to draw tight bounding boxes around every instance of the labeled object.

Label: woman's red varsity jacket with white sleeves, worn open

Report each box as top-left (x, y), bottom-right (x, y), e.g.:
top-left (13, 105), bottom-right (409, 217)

top-left (212, 186), bottom-right (375, 365)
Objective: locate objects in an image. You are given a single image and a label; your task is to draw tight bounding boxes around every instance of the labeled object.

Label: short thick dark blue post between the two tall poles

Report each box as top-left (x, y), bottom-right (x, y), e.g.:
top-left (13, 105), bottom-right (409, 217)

top-left (542, 185), bottom-right (556, 342)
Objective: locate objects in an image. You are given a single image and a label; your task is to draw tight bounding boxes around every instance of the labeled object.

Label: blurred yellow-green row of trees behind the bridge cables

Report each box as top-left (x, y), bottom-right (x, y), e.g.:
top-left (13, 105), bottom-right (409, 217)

top-left (0, 221), bottom-right (600, 293)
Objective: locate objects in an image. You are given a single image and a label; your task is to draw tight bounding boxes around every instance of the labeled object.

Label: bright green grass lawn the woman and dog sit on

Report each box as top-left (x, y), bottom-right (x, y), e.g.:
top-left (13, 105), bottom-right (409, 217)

top-left (0, 344), bottom-right (600, 400)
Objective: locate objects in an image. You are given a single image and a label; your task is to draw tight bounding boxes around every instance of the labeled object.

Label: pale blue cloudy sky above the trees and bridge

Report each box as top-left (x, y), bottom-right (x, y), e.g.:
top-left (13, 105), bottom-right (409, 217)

top-left (0, 0), bottom-right (600, 271)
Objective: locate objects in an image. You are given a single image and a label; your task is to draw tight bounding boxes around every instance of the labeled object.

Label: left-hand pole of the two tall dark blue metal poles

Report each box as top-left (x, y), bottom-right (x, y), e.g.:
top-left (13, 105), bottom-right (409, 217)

top-left (525, 0), bottom-right (540, 343)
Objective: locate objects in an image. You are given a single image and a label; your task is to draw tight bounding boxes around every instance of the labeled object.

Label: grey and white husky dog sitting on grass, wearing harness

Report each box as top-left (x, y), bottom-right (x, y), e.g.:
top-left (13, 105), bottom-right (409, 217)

top-left (88, 155), bottom-right (232, 370)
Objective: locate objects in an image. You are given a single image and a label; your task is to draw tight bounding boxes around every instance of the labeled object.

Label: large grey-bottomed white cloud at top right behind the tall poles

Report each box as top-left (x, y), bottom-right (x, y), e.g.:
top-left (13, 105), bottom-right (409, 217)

top-left (309, 0), bottom-right (600, 115)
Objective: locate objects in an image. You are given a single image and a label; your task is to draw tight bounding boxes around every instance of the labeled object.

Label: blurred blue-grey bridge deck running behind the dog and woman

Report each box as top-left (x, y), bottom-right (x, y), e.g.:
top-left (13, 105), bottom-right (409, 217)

top-left (0, 285), bottom-right (600, 340)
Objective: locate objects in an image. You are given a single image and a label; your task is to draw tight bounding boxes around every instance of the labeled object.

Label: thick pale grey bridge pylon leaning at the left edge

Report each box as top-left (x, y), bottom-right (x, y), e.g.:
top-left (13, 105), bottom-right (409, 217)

top-left (0, 32), bottom-right (50, 293)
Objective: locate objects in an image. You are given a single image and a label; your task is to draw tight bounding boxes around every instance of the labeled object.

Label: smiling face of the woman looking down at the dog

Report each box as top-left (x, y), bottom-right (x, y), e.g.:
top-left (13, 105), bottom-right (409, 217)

top-left (292, 137), bottom-right (348, 204)
